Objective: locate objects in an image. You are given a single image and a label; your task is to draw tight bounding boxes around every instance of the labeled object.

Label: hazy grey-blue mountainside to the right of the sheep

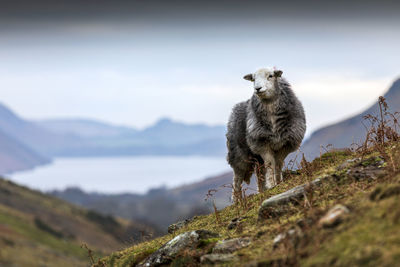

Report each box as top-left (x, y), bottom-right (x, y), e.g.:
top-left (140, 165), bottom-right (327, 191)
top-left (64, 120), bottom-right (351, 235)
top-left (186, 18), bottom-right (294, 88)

top-left (301, 79), bottom-right (400, 160)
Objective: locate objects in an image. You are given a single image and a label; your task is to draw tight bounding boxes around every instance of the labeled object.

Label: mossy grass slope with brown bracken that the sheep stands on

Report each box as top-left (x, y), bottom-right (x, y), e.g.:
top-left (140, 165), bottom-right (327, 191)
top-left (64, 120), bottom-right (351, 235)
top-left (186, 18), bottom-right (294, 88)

top-left (95, 143), bottom-right (400, 266)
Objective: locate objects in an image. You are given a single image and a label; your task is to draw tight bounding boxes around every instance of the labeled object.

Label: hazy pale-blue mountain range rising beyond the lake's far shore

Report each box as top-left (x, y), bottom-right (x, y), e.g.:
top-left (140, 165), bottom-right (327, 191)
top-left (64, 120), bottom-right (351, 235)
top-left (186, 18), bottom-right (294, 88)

top-left (36, 118), bottom-right (226, 157)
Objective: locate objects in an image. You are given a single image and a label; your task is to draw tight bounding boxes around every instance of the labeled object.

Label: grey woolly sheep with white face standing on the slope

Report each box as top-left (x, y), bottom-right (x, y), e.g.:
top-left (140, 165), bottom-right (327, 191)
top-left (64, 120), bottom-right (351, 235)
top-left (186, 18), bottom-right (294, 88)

top-left (226, 68), bottom-right (306, 202)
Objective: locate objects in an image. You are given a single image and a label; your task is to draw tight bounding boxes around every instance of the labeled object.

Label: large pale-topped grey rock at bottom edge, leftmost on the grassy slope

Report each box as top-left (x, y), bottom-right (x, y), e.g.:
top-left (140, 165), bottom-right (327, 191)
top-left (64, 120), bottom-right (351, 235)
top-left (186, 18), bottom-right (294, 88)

top-left (139, 230), bottom-right (218, 266)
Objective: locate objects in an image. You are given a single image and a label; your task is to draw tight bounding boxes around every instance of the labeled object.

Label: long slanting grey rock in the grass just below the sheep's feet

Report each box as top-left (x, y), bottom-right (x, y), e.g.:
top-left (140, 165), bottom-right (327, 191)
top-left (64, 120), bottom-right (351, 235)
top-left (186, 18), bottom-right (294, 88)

top-left (258, 176), bottom-right (329, 220)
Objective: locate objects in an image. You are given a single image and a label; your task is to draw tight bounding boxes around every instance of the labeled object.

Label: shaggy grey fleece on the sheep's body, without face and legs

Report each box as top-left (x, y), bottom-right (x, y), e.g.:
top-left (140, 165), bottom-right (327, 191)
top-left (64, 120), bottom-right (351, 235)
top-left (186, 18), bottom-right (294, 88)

top-left (226, 78), bottom-right (306, 183)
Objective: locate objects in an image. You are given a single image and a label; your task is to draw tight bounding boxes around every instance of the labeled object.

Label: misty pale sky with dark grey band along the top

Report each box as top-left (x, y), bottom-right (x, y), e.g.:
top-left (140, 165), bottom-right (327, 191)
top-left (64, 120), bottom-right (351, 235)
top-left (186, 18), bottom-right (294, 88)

top-left (0, 0), bottom-right (400, 133)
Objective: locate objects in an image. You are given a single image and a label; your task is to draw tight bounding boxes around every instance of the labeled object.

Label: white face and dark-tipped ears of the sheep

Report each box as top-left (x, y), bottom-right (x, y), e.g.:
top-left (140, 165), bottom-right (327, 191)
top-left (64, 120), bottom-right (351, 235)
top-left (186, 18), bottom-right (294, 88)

top-left (243, 68), bottom-right (282, 100)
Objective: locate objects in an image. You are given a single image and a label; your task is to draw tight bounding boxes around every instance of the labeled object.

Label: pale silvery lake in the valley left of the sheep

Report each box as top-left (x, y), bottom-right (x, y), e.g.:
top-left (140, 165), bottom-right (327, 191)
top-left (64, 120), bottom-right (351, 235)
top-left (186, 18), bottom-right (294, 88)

top-left (8, 156), bottom-right (230, 193)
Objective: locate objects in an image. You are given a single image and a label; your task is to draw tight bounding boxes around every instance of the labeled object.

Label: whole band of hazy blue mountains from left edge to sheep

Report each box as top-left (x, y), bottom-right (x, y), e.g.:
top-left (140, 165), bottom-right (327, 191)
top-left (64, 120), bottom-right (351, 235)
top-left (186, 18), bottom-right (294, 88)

top-left (0, 101), bottom-right (226, 173)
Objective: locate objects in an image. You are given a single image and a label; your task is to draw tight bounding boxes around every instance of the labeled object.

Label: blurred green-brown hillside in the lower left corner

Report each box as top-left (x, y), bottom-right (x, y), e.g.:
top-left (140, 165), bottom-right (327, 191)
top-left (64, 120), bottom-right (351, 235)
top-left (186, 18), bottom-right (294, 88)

top-left (0, 178), bottom-right (155, 266)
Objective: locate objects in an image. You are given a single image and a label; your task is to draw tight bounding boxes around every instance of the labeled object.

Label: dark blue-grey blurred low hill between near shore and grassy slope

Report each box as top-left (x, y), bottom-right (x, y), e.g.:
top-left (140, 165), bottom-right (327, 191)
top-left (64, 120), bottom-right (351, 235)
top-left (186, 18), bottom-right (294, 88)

top-left (50, 172), bottom-right (247, 233)
